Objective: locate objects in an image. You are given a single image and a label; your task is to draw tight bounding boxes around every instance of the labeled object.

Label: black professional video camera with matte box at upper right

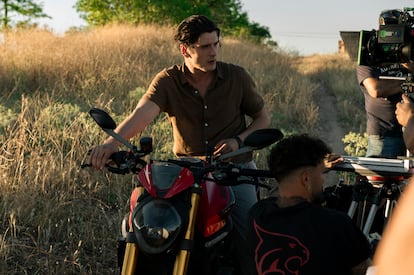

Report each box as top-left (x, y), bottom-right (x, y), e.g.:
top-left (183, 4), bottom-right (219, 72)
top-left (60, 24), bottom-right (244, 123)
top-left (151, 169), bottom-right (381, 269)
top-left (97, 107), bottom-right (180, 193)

top-left (358, 8), bottom-right (414, 66)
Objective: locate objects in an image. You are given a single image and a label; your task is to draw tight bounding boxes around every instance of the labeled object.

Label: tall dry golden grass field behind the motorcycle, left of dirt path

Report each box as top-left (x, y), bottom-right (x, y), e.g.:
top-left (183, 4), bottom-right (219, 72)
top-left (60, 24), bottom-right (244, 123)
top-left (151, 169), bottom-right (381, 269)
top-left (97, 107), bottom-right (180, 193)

top-left (0, 26), bottom-right (362, 274)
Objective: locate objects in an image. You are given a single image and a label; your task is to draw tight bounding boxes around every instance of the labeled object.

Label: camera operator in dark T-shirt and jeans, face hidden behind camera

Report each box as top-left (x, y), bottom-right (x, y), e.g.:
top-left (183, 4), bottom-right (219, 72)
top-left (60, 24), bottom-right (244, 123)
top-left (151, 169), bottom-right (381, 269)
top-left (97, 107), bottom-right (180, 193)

top-left (356, 10), bottom-right (411, 158)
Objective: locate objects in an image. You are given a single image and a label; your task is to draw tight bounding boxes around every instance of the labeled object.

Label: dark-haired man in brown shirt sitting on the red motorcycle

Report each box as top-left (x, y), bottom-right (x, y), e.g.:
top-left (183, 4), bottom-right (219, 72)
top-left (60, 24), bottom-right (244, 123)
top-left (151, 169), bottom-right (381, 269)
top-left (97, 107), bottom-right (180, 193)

top-left (90, 15), bottom-right (270, 272)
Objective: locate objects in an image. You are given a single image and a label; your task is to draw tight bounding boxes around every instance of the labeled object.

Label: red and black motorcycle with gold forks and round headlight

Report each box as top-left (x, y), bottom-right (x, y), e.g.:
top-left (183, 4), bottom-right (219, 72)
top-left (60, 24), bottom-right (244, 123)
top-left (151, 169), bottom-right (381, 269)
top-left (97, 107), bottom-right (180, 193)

top-left (82, 108), bottom-right (283, 275)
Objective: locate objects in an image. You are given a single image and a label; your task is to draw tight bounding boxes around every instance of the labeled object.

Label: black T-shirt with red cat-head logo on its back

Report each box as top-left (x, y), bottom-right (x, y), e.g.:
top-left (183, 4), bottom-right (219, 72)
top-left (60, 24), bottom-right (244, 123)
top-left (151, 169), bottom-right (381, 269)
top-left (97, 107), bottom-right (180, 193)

top-left (246, 198), bottom-right (371, 275)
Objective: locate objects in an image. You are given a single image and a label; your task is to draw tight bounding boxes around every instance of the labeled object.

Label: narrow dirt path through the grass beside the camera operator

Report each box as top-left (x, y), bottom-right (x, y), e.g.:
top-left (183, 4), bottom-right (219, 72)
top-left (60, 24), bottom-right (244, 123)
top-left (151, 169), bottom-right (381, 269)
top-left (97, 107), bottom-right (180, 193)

top-left (315, 84), bottom-right (345, 186)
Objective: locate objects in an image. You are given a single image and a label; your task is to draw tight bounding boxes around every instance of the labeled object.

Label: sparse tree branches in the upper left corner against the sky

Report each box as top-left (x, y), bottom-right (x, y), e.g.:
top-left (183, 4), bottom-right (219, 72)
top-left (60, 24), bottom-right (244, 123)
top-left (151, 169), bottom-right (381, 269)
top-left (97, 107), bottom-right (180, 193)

top-left (0, 0), bottom-right (50, 29)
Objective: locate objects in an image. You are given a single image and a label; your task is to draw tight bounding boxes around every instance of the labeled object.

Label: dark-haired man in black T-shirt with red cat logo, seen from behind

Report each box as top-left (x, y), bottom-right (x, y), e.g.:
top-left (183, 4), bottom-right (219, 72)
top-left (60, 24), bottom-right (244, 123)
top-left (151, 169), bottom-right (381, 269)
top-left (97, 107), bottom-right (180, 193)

top-left (246, 135), bottom-right (371, 275)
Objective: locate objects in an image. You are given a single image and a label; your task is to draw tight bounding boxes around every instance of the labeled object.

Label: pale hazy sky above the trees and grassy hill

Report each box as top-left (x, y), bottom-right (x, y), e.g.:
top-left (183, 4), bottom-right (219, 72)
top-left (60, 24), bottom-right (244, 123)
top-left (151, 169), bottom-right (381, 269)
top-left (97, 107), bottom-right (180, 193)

top-left (37, 0), bottom-right (414, 55)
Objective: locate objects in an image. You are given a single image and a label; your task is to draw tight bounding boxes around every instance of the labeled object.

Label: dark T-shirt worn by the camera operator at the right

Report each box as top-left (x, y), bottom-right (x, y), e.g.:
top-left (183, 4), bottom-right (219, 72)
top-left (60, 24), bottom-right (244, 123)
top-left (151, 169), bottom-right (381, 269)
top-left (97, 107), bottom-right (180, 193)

top-left (356, 64), bottom-right (409, 137)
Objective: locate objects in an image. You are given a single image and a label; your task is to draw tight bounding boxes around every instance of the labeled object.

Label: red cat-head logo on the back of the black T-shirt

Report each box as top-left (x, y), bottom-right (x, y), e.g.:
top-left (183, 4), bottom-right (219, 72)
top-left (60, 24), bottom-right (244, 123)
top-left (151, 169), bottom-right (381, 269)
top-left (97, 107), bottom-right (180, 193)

top-left (254, 221), bottom-right (309, 275)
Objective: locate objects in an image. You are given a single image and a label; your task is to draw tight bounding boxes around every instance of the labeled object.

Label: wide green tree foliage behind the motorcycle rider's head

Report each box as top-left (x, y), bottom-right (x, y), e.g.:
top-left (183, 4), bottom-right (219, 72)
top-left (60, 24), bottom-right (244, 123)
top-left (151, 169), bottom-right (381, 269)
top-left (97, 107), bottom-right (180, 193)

top-left (76, 0), bottom-right (271, 42)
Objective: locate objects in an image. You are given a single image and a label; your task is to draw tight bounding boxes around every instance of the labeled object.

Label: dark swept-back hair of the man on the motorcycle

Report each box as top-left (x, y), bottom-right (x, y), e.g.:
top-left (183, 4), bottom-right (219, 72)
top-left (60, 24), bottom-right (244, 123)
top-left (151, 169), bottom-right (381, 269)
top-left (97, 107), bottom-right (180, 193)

top-left (174, 15), bottom-right (220, 45)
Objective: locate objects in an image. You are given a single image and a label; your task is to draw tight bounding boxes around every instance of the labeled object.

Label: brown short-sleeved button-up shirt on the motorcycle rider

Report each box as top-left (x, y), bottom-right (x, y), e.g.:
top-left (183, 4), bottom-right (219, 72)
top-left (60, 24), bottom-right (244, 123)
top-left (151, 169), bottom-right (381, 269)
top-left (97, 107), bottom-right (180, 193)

top-left (144, 62), bottom-right (264, 162)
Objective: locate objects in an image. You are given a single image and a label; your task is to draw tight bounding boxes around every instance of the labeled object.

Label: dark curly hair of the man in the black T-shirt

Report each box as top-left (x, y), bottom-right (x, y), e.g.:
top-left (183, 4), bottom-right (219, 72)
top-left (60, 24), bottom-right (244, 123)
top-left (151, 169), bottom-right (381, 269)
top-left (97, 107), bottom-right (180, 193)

top-left (268, 134), bottom-right (332, 181)
